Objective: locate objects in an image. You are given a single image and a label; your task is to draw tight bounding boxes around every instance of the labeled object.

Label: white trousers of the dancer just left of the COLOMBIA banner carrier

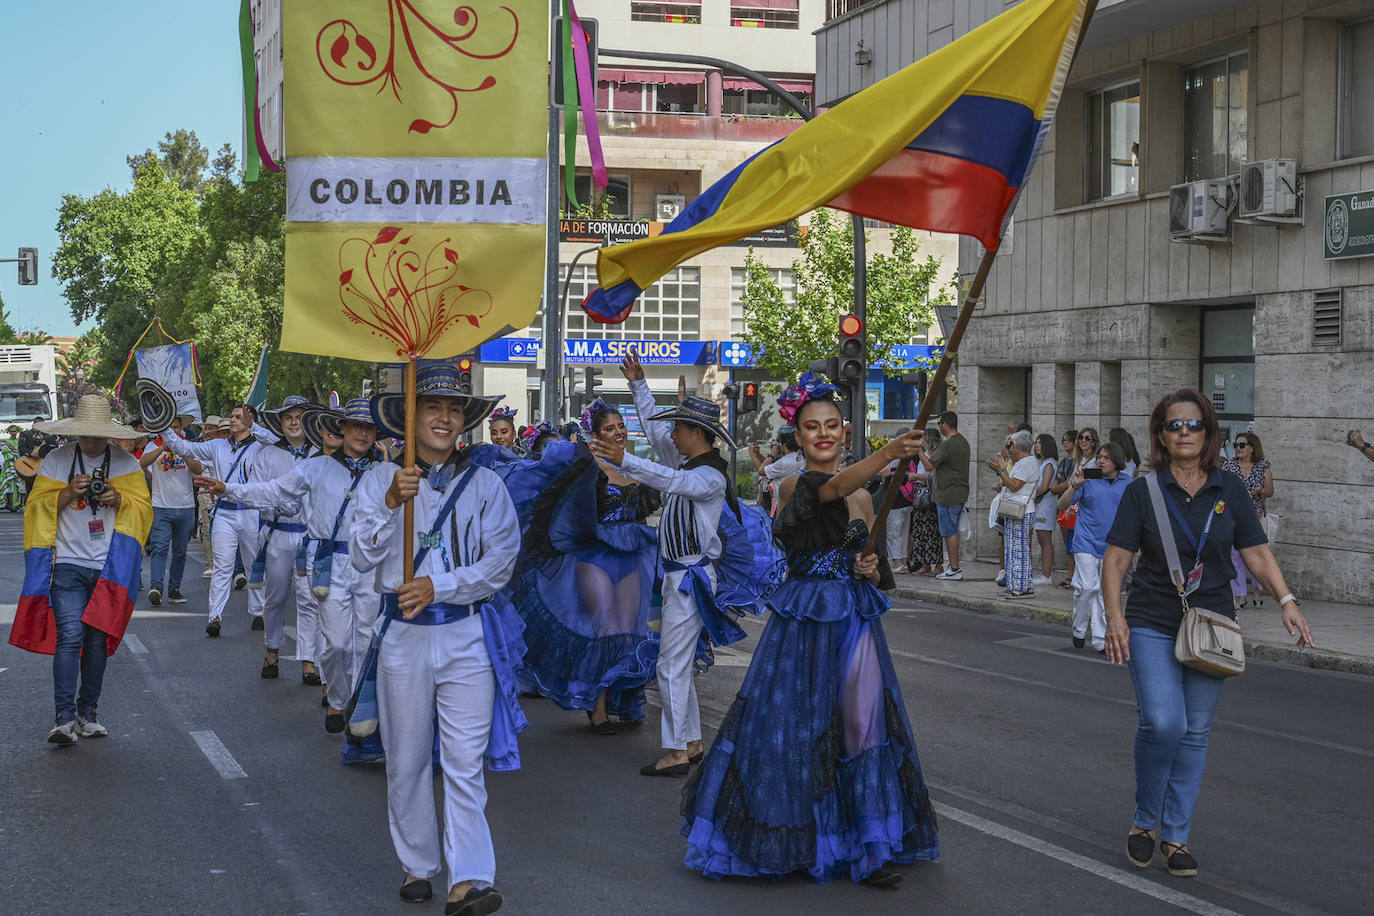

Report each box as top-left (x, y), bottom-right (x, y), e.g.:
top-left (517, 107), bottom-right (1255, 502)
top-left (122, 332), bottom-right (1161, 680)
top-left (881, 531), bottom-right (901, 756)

top-left (317, 553), bottom-right (379, 714)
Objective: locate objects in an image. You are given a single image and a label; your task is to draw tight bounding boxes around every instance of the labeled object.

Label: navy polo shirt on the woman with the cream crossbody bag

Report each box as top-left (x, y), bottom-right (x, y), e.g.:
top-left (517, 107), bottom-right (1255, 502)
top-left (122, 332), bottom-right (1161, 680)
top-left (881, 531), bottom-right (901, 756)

top-left (1107, 468), bottom-right (1268, 634)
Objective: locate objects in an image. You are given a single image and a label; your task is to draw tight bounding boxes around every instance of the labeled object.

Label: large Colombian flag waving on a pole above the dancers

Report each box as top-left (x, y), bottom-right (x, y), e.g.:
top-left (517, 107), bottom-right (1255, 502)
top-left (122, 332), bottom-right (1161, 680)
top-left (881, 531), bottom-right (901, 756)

top-left (583, 0), bottom-right (1094, 323)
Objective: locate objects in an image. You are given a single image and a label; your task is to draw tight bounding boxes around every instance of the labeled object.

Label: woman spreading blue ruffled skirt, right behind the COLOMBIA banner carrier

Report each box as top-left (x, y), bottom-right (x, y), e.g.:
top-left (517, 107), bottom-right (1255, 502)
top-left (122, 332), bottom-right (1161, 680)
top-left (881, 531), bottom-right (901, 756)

top-left (496, 398), bottom-right (658, 735)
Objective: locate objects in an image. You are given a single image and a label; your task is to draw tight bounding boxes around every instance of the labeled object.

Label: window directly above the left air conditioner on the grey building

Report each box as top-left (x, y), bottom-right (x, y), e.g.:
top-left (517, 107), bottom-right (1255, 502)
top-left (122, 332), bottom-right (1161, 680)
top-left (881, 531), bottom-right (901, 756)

top-left (1183, 52), bottom-right (1250, 181)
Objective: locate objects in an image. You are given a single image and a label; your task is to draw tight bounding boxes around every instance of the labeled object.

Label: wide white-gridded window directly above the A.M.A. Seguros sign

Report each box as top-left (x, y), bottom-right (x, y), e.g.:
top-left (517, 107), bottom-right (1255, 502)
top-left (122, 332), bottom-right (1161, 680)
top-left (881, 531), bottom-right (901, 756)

top-left (561, 262), bottom-right (701, 341)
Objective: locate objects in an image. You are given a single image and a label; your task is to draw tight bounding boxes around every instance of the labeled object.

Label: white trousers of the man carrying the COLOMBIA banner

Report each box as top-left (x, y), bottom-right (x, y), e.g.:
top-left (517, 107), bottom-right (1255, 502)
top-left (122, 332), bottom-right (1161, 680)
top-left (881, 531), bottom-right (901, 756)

top-left (376, 615), bottom-right (496, 887)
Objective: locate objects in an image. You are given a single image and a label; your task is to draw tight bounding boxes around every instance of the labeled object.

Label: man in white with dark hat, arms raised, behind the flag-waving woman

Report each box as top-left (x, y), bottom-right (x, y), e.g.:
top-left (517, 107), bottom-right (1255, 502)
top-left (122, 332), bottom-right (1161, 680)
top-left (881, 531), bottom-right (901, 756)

top-left (588, 352), bottom-right (735, 776)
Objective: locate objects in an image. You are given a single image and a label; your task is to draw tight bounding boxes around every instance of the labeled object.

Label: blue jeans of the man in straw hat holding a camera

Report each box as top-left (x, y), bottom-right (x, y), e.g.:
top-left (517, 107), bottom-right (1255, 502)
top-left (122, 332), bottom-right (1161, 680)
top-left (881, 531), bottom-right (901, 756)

top-left (49, 563), bottom-right (109, 725)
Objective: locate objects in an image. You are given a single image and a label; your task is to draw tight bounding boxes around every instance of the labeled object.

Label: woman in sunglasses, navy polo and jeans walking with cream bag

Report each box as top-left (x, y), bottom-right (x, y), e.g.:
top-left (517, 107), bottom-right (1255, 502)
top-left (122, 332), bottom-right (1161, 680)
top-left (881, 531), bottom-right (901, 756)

top-left (1102, 389), bottom-right (1312, 876)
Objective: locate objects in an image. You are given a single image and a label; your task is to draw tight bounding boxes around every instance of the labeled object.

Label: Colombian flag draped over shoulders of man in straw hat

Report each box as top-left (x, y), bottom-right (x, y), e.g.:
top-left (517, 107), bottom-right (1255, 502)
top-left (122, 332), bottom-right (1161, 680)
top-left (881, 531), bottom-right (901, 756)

top-left (10, 461), bottom-right (153, 655)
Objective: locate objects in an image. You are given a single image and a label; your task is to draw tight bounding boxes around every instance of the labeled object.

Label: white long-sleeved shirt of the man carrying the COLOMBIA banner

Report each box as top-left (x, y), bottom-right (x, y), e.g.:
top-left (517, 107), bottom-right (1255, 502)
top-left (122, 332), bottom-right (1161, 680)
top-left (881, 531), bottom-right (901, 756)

top-left (348, 461), bottom-right (519, 604)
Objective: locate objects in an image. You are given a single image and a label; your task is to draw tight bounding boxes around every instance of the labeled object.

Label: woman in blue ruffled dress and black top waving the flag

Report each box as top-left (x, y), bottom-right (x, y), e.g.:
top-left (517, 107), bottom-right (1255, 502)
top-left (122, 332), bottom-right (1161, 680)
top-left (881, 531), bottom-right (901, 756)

top-left (683, 372), bottom-right (940, 884)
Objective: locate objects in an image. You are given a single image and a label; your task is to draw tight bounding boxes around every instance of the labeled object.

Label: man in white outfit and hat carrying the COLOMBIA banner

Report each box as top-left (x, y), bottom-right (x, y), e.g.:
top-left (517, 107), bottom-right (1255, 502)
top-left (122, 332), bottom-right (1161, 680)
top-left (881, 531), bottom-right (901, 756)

top-left (349, 364), bottom-right (523, 916)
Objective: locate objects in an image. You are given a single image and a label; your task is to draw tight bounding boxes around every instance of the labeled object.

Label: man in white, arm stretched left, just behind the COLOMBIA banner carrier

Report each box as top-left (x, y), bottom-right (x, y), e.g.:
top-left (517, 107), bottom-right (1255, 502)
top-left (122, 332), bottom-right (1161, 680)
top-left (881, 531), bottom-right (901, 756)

top-left (195, 398), bottom-right (379, 735)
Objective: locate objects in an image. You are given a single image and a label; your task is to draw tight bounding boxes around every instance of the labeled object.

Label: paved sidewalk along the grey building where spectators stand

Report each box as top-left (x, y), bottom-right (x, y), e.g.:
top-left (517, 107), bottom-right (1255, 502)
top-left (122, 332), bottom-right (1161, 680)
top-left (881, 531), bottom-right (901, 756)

top-left (893, 562), bottom-right (1374, 676)
